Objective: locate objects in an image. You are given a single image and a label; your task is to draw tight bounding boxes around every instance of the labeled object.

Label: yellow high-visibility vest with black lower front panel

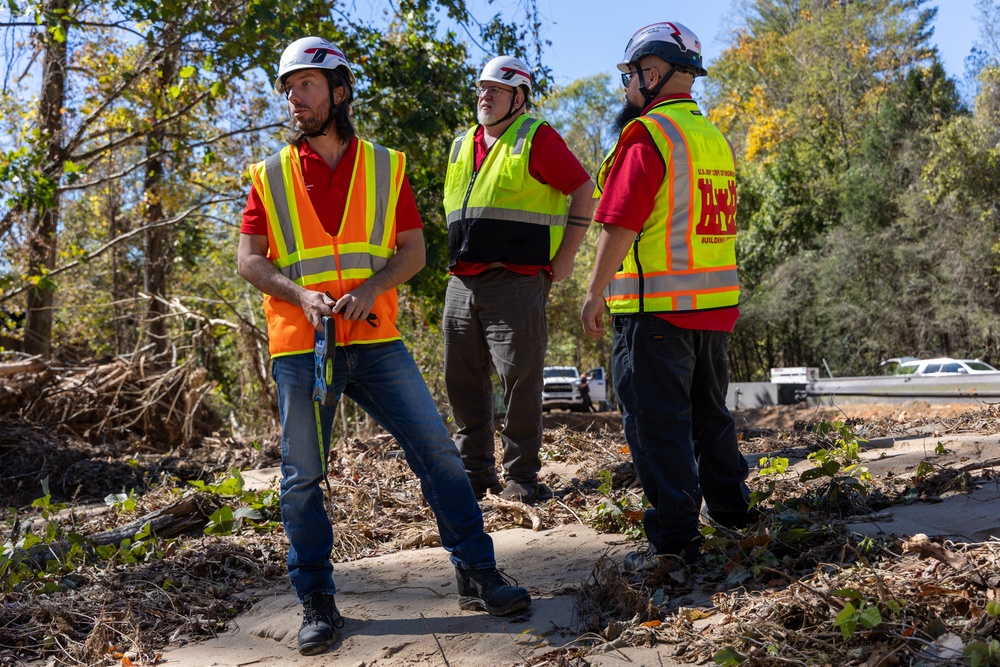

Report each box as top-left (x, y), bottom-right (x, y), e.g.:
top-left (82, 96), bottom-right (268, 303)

top-left (444, 114), bottom-right (567, 266)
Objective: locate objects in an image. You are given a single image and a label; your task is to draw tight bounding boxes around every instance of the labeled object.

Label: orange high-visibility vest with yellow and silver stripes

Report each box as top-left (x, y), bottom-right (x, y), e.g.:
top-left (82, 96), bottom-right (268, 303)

top-left (250, 139), bottom-right (406, 357)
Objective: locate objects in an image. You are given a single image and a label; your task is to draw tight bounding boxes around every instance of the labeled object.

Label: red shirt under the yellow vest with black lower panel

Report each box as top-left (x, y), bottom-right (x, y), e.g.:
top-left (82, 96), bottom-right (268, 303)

top-left (451, 125), bottom-right (590, 276)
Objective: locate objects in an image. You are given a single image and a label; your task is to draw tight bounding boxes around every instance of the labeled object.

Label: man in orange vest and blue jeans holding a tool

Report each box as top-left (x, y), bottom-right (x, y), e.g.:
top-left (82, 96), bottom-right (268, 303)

top-left (239, 37), bottom-right (531, 655)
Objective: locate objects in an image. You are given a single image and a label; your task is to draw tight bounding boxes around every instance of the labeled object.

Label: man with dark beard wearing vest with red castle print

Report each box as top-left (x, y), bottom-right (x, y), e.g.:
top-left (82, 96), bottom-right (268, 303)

top-left (581, 23), bottom-right (754, 572)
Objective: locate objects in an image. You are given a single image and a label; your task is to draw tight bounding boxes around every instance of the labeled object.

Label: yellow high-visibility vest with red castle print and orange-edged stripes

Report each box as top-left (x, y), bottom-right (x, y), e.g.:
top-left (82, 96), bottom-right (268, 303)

top-left (597, 99), bottom-right (740, 314)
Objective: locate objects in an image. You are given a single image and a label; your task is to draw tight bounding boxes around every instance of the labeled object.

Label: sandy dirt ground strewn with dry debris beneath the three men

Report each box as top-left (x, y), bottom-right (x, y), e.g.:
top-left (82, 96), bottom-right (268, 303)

top-left (7, 392), bottom-right (1000, 667)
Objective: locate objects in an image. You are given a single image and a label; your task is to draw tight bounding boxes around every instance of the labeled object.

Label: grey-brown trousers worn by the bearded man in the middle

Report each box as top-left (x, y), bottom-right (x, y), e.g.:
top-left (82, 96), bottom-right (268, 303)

top-left (441, 269), bottom-right (552, 489)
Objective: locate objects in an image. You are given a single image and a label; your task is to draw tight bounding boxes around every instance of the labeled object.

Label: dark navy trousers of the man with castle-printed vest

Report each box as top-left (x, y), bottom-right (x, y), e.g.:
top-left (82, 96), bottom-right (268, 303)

top-left (611, 314), bottom-right (750, 554)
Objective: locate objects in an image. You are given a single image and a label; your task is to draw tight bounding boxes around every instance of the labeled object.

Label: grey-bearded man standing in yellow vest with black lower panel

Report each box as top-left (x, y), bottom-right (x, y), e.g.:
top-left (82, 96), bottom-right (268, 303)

top-left (442, 56), bottom-right (594, 503)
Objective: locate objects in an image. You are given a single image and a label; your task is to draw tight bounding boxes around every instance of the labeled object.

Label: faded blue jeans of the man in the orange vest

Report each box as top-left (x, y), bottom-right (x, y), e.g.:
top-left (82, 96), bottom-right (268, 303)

top-left (271, 341), bottom-right (496, 601)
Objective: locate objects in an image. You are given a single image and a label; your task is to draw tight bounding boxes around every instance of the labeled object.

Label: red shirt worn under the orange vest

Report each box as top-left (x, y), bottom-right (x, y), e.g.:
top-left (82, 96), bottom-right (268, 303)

top-left (240, 137), bottom-right (424, 236)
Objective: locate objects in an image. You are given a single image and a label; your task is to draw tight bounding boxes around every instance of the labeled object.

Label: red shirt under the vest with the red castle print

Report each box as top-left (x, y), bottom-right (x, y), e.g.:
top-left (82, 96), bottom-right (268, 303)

top-left (594, 95), bottom-right (740, 331)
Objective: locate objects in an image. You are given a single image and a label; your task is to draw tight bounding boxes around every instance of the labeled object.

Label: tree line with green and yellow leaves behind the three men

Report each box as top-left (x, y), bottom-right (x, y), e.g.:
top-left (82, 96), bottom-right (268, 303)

top-left (0, 0), bottom-right (1000, 430)
